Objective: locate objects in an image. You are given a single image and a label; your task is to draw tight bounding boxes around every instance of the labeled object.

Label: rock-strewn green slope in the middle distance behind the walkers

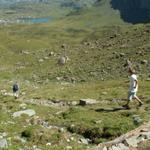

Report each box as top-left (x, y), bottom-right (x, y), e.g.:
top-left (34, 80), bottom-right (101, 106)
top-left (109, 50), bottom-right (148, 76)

top-left (0, 25), bottom-right (150, 81)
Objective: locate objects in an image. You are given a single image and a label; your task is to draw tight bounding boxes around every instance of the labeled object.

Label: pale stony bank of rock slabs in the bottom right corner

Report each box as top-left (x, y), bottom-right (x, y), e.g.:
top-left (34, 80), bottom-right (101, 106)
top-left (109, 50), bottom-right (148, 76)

top-left (91, 122), bottom-right (150, 150)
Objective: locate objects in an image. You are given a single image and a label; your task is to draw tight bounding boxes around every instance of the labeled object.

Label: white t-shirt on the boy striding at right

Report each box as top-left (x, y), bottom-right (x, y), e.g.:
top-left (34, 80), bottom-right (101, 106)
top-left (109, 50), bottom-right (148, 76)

top-left (129, 74), bottom-right (138, 92)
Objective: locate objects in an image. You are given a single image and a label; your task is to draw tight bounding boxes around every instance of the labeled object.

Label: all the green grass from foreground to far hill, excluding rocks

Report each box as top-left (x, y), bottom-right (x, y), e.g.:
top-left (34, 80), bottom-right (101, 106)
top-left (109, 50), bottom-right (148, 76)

top-left (0, 0), bottom-right (150, 150)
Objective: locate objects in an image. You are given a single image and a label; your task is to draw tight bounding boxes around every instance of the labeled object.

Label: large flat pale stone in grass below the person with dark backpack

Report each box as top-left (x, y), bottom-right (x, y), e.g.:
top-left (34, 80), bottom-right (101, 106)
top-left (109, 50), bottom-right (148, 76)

top-left (13, 109), bottom-right (36, 118)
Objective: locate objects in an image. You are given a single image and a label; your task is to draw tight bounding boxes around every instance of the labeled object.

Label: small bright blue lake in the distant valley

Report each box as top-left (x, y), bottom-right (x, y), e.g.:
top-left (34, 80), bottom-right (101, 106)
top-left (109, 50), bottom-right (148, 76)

top-left (17, 17), bottom-right (53, 24)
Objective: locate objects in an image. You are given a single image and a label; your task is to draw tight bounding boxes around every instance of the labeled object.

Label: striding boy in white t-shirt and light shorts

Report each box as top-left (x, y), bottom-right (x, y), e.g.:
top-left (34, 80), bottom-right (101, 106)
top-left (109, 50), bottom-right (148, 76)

top-left (124, 68), bottom-right (143, 108)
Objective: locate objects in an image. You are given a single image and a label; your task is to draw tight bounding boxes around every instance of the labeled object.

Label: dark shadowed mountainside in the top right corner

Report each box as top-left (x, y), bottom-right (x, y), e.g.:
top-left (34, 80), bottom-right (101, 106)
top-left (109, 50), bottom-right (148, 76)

top-left (111, 0), bottom-right (150, 24)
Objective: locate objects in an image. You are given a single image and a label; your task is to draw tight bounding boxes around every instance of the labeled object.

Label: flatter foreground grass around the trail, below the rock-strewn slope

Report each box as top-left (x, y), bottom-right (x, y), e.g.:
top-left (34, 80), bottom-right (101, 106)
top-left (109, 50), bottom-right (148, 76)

top-left (0, 80), bottom-right (150, 150)
